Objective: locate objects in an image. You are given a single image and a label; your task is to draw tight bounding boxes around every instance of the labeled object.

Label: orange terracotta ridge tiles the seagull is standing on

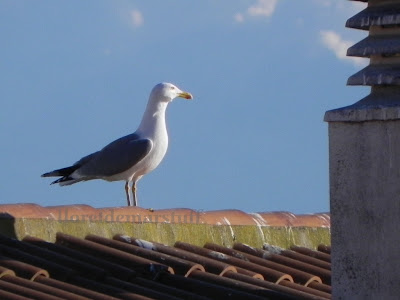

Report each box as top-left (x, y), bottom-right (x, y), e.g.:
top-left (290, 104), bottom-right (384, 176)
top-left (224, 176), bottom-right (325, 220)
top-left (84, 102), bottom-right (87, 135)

top-left (0, 203), bottom-right (330, 227)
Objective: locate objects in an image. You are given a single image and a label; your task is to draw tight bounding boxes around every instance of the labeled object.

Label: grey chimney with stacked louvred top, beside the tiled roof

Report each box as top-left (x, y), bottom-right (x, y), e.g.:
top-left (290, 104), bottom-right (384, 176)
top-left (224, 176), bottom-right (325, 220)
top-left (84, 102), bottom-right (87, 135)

top-left (325, 0), bottom-right (400, 300)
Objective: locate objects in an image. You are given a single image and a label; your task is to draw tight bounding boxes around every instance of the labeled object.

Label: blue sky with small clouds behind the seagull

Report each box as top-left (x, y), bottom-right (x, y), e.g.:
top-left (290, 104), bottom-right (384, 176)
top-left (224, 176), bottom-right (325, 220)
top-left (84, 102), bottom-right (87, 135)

top-left (0, 0), bottom-right (369, 213)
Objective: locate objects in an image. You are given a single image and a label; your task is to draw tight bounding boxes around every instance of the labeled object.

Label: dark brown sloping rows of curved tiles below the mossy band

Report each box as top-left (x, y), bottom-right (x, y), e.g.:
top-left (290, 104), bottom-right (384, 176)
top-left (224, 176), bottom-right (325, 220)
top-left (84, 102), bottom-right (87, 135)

top-left (0, 232), bottom-right (331, 300)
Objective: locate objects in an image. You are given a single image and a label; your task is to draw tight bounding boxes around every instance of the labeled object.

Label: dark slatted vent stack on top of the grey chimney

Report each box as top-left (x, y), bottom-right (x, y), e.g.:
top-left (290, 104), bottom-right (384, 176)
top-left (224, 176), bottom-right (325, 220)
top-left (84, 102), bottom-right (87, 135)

top-left (346, 0), bottom-right (400, 107)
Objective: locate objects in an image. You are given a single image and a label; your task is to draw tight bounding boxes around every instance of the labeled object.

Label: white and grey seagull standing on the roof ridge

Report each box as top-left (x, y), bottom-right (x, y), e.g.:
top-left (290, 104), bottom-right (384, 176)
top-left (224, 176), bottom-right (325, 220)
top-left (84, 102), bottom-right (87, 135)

top-left (42, 82), bottom-right (193, 206)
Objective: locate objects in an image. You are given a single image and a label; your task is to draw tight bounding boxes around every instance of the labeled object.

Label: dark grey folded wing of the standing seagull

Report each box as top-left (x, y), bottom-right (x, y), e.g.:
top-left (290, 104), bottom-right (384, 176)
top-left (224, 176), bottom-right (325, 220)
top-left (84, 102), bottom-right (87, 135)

top-left (78, 133), bottom-right (153, 177)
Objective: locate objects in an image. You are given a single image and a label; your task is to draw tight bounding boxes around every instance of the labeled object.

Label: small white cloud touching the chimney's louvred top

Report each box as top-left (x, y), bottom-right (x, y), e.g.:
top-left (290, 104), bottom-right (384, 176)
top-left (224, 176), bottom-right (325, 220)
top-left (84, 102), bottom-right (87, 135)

top-left (320, 30), bottom-right (367, 66)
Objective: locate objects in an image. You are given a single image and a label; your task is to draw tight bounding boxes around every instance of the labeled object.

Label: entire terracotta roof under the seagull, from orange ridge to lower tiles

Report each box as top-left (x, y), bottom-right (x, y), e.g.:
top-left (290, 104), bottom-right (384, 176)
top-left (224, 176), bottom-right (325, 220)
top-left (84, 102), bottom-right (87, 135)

top-left (0, 204), bottom-right (331, 300)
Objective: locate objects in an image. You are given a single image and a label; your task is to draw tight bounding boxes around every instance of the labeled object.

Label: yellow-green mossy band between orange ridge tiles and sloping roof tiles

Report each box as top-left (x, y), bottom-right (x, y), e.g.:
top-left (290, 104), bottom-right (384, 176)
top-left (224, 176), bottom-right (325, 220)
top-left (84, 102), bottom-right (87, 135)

top-left (5, 218), bottom-right (330, 249)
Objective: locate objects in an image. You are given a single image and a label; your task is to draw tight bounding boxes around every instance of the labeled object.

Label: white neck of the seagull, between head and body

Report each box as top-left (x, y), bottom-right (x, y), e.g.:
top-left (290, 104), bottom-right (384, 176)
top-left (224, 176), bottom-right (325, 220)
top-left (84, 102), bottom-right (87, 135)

top-left (136, 98), bottom-right (168, 137)
